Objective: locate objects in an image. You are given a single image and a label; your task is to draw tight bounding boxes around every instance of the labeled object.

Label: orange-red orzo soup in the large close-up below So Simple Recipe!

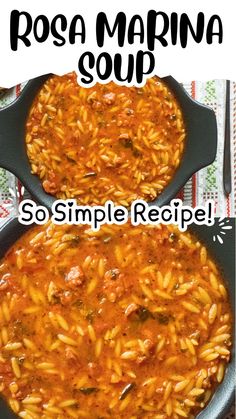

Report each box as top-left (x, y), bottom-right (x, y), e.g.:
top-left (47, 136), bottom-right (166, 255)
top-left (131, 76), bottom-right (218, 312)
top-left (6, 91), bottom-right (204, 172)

top-left (0, 223), bottom-right (231, 419)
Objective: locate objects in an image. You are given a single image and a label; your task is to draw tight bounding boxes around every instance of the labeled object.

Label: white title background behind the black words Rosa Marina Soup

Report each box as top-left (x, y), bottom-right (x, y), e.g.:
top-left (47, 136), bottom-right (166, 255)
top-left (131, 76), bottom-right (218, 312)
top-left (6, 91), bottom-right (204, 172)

top-left (0, 0), bottom-right (236, 87)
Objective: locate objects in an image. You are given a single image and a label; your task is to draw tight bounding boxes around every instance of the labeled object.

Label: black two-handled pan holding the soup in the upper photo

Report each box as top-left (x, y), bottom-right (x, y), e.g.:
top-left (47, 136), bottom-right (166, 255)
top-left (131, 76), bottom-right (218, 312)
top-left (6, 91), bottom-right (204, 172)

top-left (0, 74), bottom-right (217, 209)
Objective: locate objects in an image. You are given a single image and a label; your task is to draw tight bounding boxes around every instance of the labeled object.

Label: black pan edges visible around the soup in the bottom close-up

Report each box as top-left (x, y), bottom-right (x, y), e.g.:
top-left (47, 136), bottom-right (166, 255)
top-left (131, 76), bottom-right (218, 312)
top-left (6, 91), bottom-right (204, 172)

top-left (0, 218), bottom-right (235, 419)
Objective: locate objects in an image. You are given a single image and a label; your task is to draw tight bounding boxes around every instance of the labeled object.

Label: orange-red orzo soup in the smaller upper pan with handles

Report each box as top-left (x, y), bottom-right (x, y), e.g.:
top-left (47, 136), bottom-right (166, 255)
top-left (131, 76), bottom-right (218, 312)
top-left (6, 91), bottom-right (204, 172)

top-left (26, 73), bottom-right (185, 206)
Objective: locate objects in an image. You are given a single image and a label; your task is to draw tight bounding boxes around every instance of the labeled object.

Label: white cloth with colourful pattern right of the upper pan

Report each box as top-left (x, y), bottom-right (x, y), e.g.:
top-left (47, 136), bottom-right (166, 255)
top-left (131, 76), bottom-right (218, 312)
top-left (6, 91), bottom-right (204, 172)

top-left (182, 80), bottom-right (236, 217)
